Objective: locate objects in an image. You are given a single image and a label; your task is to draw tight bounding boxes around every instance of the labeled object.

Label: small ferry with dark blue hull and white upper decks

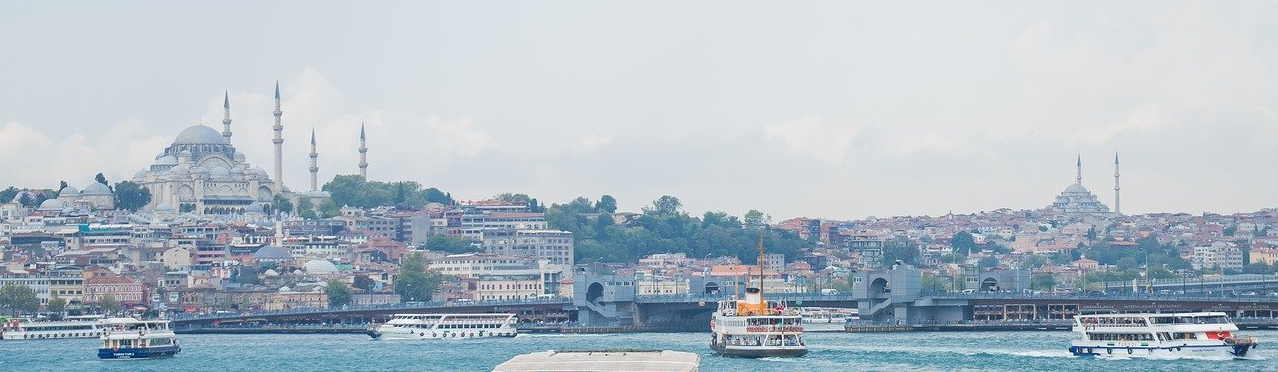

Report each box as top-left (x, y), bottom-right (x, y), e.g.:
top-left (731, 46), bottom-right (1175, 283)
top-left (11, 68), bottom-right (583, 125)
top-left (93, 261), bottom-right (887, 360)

top-left (97, 318), bottom-right (181, 359)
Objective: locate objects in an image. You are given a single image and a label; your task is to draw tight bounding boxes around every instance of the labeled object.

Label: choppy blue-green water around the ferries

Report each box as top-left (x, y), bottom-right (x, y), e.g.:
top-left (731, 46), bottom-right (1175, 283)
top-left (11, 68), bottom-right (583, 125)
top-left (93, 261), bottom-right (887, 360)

top-left (0, 331), bottom-right (1278, 372)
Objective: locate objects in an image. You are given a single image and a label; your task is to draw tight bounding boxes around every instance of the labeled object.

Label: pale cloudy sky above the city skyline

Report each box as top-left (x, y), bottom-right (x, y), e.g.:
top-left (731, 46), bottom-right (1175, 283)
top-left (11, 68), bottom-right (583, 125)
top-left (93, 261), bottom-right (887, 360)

top-left (0, 1), bottom-right (1278, 220)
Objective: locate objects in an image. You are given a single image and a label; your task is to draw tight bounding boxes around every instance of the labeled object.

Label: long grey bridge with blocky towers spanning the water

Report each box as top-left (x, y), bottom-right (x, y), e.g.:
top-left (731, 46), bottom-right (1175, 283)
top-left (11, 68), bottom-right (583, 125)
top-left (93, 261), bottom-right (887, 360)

top-left (173, 267), bottom-right (1278, 330)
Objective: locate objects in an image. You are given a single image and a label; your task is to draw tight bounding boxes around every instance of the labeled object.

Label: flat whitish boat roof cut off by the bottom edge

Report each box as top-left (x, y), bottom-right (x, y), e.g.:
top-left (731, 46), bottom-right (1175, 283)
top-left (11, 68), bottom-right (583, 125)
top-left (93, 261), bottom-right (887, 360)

top-left (492, 350), bottom-right (702, 372)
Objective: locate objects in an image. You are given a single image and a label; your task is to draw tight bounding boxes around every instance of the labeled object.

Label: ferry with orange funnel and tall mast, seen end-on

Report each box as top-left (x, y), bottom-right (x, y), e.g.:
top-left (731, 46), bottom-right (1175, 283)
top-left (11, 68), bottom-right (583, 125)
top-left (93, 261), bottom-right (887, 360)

top-left (711, 230), bottom-right (808, 358)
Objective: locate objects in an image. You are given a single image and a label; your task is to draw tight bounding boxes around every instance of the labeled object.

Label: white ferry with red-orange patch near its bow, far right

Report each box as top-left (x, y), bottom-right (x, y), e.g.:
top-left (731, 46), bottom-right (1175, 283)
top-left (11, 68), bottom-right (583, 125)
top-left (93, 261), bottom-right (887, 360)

top-left (1070, 312), bottom-right (1256, 357)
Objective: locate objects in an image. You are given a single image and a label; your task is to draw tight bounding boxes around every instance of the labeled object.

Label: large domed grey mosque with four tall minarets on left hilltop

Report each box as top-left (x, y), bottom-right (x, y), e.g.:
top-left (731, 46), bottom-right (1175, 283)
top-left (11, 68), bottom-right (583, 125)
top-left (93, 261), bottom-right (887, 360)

top-left (133, 83), bottom-right (368, 215)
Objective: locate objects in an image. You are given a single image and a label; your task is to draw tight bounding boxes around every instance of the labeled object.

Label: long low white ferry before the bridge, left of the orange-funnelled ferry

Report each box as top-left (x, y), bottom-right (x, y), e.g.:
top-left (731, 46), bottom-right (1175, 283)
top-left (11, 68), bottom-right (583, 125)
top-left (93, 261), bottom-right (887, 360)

top-left (368, 313), bottom-right (519, 340)
